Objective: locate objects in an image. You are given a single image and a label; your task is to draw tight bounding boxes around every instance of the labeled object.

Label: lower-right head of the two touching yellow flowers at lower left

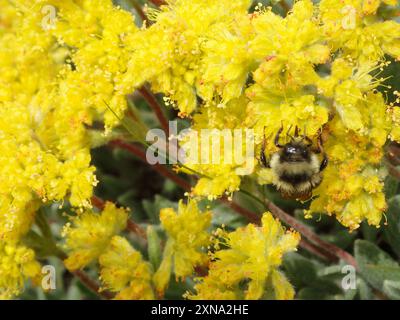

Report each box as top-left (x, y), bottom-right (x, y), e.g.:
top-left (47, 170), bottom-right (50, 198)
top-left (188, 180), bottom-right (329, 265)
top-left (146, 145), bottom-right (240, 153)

top-left (99, 236), bottom-right (154, 300)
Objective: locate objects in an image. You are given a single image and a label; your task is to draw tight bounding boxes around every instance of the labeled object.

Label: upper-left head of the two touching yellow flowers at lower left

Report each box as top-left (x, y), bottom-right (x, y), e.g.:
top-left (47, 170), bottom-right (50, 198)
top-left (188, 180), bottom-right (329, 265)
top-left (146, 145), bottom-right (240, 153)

top-left (63, 202), bottom-right (128, 270)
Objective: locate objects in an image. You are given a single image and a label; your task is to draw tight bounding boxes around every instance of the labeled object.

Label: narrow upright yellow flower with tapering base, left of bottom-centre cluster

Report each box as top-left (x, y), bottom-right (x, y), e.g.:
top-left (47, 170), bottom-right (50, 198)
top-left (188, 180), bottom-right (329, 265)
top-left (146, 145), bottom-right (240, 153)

top-left (154, 200), bottom-right (211, 293)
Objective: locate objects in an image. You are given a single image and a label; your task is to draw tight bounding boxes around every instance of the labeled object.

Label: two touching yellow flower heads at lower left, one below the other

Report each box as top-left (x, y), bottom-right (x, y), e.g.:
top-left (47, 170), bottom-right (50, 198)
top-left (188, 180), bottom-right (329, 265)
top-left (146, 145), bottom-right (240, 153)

top-left (63, 202), bottom-right (158, 300)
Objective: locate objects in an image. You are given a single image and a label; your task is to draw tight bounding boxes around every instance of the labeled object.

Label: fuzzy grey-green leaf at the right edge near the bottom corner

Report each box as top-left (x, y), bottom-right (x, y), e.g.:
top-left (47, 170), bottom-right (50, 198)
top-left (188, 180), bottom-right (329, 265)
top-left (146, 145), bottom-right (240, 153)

top-left (354, 240), bottom-right (400, 291)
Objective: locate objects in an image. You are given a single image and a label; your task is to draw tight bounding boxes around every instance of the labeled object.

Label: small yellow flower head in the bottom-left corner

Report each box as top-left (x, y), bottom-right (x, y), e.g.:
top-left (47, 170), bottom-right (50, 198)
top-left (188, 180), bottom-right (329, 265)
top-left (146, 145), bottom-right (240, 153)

top-left (0, 241), bottom-right (41, 299)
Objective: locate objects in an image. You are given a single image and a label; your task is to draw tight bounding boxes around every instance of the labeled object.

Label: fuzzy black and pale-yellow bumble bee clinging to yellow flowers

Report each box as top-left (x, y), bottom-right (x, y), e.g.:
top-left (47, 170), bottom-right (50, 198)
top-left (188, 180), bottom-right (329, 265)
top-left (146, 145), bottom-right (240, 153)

top-left (260, 127), bottom-right (328, 200)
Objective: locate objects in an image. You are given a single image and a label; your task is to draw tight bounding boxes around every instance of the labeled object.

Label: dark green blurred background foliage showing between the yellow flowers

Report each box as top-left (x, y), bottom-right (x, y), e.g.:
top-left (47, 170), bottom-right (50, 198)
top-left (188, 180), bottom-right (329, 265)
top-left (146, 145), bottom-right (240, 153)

top-left (20, 0), bottom-right (400, 300)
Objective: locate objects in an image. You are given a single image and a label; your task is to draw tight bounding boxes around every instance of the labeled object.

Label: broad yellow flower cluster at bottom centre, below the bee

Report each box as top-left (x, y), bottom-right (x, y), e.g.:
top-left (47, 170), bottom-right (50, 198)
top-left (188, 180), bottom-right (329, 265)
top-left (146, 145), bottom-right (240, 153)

top-left (188, 212), bottom-right (300, 300)
